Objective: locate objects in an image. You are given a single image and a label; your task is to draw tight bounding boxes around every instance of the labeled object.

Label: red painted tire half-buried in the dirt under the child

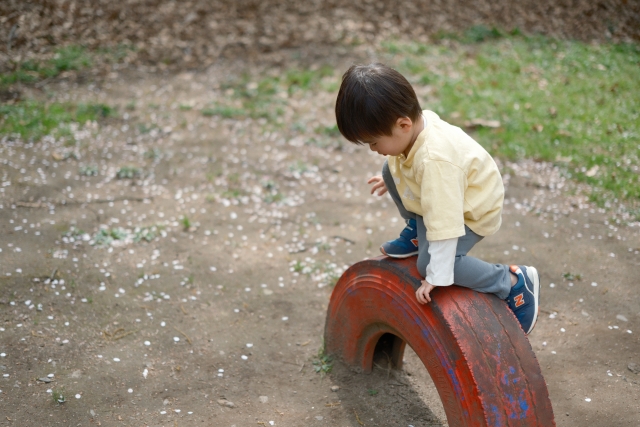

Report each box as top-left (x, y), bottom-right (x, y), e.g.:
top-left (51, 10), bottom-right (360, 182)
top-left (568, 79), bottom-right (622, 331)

top-left (325, 257), bottom-right (555, 427)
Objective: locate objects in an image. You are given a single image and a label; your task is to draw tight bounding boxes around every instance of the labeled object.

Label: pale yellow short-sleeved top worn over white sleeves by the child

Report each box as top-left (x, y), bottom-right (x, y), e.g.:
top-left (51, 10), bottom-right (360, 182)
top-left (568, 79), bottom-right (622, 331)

top-left (387, 110), bottom-right (504, 241)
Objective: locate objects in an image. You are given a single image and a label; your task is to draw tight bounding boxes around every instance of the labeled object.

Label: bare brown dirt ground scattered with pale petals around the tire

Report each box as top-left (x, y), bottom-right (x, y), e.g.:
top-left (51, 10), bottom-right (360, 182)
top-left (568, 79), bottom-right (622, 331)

top-left (0, 46), bottom-right (640, 427)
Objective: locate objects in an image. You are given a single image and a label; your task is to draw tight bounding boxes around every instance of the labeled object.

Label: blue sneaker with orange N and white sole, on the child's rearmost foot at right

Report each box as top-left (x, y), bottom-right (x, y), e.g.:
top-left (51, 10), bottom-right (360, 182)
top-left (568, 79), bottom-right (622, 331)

top-left (507, 265), bottom-right (540, 335)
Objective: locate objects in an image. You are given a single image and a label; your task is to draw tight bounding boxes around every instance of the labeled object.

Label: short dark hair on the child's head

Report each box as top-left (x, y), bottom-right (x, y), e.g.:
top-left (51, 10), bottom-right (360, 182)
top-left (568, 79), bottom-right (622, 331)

top-left (336, 63), bottom-right (422, 144)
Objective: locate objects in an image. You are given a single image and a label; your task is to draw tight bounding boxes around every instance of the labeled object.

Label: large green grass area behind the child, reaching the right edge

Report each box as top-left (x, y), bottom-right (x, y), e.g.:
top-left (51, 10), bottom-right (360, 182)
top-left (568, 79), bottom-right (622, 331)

top-left (383, 34), bottom-right (640, 211)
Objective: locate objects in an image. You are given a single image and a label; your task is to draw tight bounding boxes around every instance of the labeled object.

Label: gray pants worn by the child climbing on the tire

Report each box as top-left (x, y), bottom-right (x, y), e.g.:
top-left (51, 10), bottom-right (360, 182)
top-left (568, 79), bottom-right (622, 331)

top-left (382, 161), bottom-right (511, 299)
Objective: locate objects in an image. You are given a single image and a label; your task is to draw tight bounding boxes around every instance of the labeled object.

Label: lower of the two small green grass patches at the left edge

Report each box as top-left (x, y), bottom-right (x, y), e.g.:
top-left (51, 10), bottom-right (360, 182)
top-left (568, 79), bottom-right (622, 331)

top-left (0, 100), bottom-right (114, 140)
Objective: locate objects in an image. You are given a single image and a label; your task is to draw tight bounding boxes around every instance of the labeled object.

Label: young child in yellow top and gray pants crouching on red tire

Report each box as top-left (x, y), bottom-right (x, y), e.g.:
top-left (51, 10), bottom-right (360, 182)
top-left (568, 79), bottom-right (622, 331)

top-left (336, 64), bottom-right (540, 334)
